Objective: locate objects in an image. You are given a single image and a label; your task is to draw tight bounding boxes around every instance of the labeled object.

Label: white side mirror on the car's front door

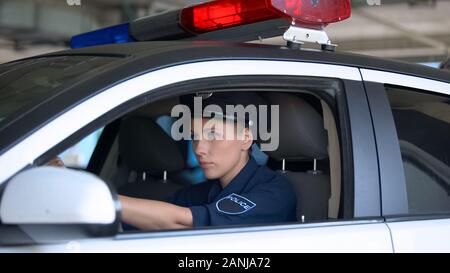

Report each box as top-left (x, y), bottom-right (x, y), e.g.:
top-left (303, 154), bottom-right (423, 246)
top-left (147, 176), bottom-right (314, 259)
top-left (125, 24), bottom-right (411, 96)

top-left (0, 167), bottom-right (120, 244)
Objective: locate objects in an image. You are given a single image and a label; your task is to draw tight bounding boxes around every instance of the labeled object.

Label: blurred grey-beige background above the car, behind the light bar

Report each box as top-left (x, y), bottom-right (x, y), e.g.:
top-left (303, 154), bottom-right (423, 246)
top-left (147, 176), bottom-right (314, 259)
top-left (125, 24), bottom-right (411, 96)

top-left (0, 0), bottom-right (450, 66)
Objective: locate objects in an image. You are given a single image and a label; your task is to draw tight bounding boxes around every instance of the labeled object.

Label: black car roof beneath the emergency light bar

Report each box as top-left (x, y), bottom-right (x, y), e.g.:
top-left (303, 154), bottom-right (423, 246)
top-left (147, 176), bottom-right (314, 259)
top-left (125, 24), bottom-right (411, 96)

top-left (33, 41), bottom-right (450, 82)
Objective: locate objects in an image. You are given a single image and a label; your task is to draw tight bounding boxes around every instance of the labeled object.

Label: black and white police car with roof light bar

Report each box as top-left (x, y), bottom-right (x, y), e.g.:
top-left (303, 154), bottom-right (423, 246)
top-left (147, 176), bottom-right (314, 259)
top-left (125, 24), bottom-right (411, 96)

top-left (0, 0), bottom-right (450, 252)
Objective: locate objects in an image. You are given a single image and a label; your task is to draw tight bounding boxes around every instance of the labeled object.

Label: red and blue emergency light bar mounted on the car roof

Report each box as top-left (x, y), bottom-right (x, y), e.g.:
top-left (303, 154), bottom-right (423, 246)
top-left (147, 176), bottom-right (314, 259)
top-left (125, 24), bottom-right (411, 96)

top-left (70, 0), bottom-right (351, 48)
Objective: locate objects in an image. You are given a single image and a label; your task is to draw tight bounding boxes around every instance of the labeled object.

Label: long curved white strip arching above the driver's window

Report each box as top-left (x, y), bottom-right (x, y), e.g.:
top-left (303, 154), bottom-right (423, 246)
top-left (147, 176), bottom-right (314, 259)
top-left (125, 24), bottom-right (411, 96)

top-left (0, 60), bottom-right (361, 184)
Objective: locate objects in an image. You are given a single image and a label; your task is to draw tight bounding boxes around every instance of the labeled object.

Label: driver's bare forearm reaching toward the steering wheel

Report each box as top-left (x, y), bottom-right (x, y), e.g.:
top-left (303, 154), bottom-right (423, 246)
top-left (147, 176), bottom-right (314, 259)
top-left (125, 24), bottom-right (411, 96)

top-left (119, 195), bottom-right (193, 230)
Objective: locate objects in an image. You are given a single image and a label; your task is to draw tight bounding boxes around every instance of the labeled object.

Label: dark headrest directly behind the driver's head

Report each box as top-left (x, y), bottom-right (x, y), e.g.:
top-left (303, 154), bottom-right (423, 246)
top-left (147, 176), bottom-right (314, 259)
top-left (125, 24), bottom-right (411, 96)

top-left (263, 93), bottom-right (328, 161)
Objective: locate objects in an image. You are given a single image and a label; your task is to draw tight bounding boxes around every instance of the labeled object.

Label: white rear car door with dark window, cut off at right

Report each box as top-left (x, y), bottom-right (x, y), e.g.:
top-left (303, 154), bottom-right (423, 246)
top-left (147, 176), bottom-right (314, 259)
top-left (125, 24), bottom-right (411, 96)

top-left (361, 69), bottom-right (450, 252)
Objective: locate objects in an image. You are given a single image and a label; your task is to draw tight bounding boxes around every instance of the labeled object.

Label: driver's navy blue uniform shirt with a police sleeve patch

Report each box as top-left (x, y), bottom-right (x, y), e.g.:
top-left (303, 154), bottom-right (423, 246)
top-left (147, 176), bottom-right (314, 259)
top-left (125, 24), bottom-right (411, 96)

top-left (167, 158), bottom-right (297, 227)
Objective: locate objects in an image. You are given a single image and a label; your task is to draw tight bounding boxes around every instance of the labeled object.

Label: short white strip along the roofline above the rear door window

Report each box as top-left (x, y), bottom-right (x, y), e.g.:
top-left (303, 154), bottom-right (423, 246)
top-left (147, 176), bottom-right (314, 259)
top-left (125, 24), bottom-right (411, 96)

top-left (361, 69), bottom-right (450, 95)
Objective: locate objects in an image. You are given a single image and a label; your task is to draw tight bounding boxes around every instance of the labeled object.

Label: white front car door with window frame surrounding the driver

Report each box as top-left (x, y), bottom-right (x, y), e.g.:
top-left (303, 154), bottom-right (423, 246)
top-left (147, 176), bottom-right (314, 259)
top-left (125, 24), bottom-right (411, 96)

top-left (0, 56), bottom-right (392, 252)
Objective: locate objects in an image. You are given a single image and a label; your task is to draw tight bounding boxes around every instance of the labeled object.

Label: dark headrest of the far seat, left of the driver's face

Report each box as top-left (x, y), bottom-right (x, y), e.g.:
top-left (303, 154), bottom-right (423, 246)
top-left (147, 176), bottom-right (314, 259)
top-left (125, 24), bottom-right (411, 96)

top-left (119, 117), bottom-right (184, 172)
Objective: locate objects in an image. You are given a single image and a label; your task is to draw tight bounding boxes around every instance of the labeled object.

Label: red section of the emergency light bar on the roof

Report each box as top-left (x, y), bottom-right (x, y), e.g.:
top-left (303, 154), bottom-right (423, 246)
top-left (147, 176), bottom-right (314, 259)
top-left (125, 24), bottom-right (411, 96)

top-left (180, 0), bottom-right (351, 34)
